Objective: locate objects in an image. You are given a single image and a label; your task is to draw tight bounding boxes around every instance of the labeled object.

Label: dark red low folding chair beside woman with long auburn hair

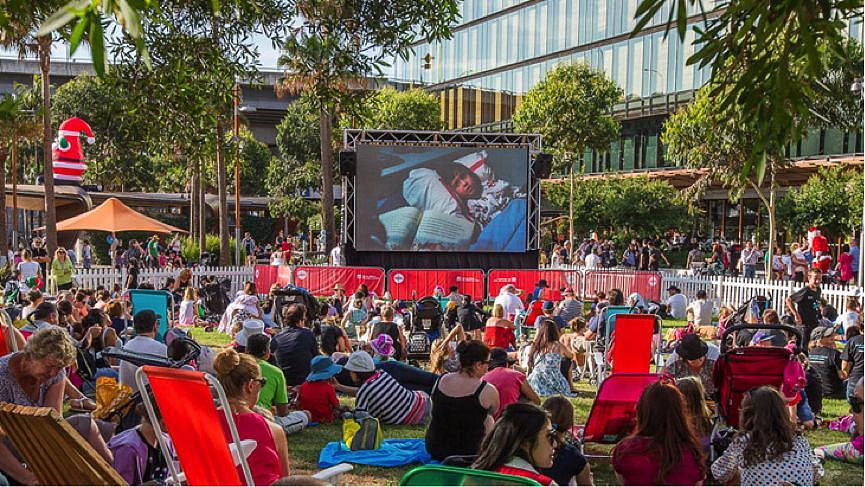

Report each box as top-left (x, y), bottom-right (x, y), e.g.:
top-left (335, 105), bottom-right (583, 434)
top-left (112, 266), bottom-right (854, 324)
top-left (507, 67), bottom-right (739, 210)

top-left (582, 374), bottom-right (660, 444)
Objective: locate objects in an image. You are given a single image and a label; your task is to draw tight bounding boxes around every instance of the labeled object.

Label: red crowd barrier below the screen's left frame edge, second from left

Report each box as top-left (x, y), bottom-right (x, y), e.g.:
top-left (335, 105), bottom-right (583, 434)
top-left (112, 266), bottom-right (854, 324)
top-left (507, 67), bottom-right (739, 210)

top-left (294, 265), bottom-right (384, 296)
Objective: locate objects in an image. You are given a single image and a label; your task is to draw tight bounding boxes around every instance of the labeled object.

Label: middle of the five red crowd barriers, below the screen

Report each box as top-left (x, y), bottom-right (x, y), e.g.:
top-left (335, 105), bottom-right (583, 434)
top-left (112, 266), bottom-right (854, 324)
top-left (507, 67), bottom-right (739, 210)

top-left (387, 269), bottom-right (484, 299)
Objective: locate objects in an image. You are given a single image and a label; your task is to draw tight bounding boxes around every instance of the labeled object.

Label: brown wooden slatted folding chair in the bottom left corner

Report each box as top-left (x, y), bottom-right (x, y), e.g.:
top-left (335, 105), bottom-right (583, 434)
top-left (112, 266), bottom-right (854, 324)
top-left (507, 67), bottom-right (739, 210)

top-left (0, 403), bottom-right (126, 485)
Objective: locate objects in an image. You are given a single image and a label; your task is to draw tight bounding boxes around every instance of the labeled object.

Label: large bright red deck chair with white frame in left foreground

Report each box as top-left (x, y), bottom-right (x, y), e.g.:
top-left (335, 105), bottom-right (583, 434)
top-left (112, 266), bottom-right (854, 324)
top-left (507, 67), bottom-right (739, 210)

top-left (135, 365), bottom-right (254, 485)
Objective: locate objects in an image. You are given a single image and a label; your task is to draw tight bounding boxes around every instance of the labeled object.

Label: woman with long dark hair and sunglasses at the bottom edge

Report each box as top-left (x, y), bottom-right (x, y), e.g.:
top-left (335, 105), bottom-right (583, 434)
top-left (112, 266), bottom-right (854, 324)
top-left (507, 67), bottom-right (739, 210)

top-left (472, 403), bottom-right (558, 485)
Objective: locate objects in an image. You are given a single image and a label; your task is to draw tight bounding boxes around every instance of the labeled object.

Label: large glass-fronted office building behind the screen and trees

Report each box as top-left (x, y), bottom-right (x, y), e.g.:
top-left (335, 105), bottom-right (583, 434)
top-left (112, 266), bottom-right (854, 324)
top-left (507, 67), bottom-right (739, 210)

top-left (392, 0), bottom-right (861, 172)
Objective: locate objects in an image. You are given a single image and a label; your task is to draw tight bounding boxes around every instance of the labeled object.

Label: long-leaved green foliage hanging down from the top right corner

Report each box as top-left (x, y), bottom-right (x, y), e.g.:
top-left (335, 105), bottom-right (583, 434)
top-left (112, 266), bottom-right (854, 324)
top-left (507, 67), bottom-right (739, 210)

top-left (634, 0), bottom-right (862, 185)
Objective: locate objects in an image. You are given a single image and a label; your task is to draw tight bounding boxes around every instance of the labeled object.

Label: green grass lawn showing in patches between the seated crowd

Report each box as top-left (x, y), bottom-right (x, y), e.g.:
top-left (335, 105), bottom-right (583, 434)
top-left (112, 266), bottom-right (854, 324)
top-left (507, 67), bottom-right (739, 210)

top-left (193, 330), bottom-right (863, 485)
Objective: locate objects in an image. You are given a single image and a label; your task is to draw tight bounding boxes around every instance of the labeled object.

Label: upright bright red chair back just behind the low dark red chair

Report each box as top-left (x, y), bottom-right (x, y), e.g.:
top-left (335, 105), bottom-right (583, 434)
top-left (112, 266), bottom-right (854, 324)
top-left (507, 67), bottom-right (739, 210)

top-left (610, 314), bottom-right (655, 374)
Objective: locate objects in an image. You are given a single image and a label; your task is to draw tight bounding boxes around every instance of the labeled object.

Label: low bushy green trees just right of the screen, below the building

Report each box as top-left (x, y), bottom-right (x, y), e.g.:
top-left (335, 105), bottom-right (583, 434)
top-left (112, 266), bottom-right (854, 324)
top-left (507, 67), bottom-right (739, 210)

top-left (542, 175), bottom-right (694, 243)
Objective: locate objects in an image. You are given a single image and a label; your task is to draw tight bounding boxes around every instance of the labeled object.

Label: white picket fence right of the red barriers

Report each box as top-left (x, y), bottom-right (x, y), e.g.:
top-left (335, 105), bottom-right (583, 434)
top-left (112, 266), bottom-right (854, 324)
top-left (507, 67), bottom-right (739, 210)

top-left (662, 271), bottom-right (862, 312)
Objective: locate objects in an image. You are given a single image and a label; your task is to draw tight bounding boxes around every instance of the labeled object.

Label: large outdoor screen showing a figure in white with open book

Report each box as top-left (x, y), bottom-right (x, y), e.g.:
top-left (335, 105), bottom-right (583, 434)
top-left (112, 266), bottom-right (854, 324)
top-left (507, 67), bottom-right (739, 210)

top-left (355, 145), bottom-right (529, 252)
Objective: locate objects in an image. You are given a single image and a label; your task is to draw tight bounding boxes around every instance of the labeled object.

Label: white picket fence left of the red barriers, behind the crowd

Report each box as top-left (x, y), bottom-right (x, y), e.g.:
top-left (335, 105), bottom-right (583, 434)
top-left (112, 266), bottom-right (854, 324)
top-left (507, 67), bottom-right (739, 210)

top-left (57, 267), bottom-right (254, 295)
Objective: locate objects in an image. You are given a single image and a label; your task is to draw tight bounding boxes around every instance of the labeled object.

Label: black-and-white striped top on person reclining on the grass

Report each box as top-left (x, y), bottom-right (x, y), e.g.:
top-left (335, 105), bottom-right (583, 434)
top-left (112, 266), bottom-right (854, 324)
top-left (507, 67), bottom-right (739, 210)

top-left (355, 370), bottom-right (415, 424)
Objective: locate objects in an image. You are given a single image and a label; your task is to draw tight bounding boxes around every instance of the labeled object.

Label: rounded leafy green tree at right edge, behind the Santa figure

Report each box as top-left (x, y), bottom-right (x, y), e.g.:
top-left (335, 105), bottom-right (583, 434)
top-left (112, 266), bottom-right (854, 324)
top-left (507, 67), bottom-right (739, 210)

top-left (778, 166), bottom-right (863, 240)
